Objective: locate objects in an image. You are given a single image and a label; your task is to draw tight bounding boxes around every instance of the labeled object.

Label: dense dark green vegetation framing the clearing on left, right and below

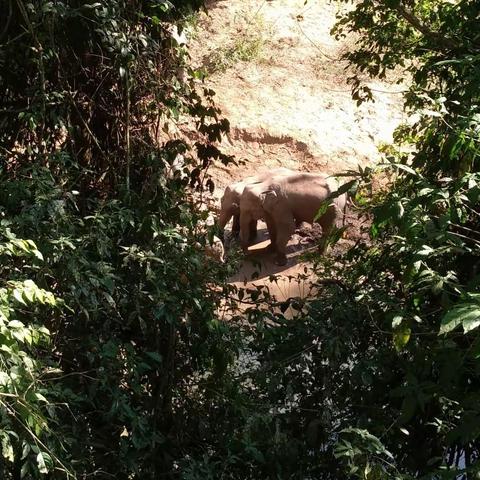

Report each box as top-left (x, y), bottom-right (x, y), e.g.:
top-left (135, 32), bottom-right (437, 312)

top-left (0, 0), bottom-right (480, 480)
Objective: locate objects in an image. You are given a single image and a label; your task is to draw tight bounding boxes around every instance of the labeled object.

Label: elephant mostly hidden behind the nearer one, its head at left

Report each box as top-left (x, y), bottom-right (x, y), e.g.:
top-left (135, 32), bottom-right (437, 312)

top-left (217, 167), bottom-right (292, 241)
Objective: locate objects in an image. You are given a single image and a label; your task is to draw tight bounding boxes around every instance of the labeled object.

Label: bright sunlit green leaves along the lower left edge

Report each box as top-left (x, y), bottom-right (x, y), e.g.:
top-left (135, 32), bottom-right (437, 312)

top-left (0, 230), bottom-right (70, 478)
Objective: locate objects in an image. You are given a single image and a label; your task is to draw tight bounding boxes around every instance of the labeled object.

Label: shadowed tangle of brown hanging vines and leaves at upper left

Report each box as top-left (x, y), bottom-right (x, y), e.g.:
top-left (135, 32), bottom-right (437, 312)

top-left (0, 0), bottom-right (228, 192)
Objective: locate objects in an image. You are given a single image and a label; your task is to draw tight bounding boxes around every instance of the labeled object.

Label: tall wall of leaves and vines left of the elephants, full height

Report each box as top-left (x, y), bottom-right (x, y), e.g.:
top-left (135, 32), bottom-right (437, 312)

top-left (0, 0), bottom-right (239, 480)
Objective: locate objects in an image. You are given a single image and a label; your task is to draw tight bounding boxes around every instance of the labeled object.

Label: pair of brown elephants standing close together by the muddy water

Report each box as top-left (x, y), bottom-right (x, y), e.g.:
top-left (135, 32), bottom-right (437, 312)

top-left (218, 168), bottom-right (347, 265)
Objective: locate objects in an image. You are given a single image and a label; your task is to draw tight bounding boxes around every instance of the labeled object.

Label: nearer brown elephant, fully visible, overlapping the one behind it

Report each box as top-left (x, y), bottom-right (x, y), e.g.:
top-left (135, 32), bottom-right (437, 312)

top-left (240, 172), bottom-right (347, 265)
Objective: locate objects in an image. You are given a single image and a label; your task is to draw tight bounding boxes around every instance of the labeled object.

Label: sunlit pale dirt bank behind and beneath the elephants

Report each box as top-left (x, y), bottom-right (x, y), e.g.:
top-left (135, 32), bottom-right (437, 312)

top-left (189, 0), bottom-right (405, 306)
